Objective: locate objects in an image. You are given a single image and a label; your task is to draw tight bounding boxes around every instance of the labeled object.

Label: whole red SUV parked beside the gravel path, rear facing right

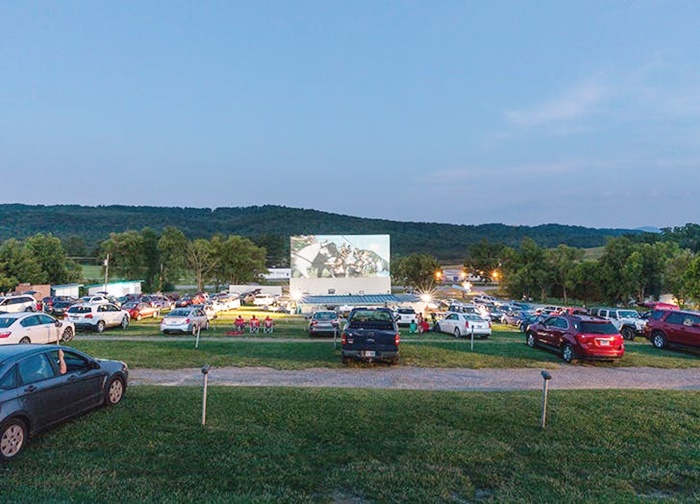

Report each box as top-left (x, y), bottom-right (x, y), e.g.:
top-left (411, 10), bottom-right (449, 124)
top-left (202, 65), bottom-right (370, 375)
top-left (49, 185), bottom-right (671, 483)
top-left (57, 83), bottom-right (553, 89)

top-left (525, 315), bottom-right (625, 362)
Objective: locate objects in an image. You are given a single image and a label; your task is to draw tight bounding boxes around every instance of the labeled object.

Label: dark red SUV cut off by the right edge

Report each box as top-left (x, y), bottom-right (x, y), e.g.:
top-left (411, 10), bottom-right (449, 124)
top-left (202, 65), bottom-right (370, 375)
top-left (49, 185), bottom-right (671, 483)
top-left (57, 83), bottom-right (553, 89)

top-left (644, 310), bottom-right (700, 348)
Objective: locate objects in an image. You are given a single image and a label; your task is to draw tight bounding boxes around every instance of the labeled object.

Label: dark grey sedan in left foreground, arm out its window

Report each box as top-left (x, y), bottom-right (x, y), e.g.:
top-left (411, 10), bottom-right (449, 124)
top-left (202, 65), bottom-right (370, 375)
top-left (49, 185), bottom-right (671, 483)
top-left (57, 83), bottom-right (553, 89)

top-left (0, 344), bottom-right (129, 461)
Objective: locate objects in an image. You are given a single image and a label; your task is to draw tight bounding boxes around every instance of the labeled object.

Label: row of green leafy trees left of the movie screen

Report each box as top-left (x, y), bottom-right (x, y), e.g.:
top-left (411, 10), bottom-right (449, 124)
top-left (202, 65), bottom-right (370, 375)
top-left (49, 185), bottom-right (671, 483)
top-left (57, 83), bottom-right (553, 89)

top-left (0, 226), bottom-right (268, 292)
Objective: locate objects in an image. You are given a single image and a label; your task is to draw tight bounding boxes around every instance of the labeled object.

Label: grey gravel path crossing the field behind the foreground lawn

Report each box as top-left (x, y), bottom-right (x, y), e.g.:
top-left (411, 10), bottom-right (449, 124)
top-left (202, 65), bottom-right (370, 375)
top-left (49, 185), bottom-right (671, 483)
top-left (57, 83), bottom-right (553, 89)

top-left (130, 366), bottom-right (700, 391)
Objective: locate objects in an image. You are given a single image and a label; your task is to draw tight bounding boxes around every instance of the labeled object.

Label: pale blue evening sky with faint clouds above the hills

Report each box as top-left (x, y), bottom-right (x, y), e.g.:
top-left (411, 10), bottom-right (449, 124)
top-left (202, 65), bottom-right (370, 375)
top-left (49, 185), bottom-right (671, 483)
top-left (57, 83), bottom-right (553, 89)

top-left (0, 0), bottom-right (700, 228)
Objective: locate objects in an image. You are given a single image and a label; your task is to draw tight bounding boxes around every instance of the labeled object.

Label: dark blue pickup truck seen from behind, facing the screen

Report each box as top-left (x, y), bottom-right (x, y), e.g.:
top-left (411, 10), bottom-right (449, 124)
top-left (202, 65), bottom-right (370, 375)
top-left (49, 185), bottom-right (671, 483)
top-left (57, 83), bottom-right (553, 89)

top-left (341, 308), bottom-right (400, 364)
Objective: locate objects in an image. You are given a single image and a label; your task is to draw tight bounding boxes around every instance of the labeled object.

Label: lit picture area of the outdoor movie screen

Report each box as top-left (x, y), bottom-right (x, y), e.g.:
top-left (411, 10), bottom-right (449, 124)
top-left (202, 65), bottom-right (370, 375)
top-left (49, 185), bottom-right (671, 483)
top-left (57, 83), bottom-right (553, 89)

top-left (290, 235), bottom-right (390, 278)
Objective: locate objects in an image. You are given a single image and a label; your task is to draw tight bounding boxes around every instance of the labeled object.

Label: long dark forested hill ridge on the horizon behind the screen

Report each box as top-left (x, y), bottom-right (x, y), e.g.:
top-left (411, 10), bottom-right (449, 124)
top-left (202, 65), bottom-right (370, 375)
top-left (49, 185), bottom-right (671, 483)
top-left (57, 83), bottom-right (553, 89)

top-left (0, 204), bottom-right (636, 260)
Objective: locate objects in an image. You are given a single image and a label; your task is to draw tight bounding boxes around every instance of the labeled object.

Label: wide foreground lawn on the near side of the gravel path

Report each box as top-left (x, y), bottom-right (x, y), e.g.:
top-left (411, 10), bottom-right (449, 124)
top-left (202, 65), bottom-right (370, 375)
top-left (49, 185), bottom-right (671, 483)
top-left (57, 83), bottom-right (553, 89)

top-left (0, 387), bottom-right (700, 503)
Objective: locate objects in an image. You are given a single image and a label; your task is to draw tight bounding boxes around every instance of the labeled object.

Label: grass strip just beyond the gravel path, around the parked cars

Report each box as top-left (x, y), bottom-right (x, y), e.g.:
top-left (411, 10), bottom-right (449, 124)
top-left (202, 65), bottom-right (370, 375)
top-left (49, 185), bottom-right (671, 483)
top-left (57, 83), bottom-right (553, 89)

top-left (72, 318), bottom-right (700, 369)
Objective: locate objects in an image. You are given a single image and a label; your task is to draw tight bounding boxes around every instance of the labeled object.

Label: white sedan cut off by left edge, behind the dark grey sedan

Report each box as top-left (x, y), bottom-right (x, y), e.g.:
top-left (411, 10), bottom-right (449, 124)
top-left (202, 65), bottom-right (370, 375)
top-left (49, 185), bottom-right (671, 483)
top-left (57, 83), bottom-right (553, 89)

top-left (0, 312), bottom-right (75, 345)
